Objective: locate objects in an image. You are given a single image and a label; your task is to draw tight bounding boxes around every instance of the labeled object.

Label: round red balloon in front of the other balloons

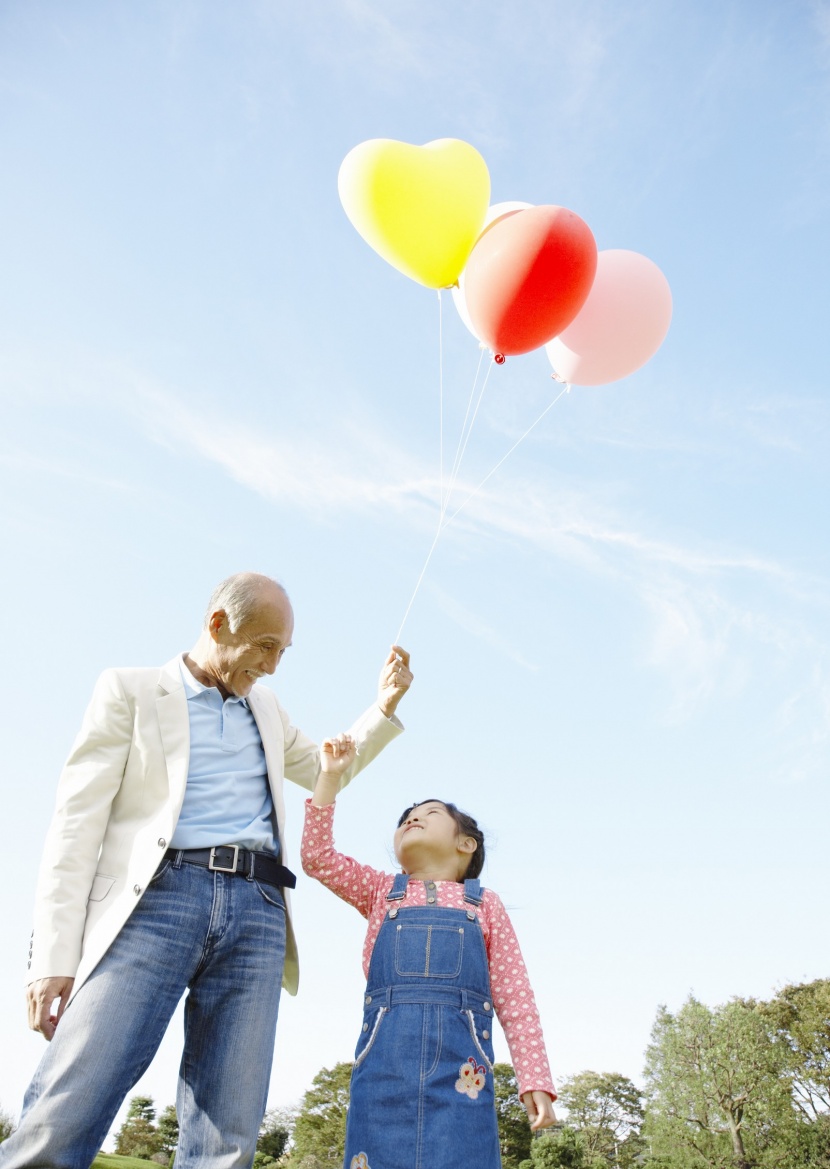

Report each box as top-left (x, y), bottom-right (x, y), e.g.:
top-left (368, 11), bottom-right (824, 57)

top-left (464, 207), bottom-right (596, 355)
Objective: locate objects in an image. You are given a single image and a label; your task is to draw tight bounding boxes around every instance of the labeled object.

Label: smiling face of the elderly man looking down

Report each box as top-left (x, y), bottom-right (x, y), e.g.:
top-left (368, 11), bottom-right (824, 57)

top-left (205, 588), bottom-right (293, 698)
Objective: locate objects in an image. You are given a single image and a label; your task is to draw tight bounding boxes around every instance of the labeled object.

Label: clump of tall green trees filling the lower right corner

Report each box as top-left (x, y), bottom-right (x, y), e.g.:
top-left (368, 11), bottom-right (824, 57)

top-left (644, 980), bottom-right (830, 1169)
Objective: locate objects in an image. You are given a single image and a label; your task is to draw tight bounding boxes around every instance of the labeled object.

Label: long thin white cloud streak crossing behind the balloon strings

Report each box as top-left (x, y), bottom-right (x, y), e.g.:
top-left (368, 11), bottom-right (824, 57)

top-left (130, 380), bottom-right (796, 586)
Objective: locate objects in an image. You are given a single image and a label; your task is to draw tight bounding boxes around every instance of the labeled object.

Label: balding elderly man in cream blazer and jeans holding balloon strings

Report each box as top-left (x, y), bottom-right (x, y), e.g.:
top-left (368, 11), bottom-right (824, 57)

top-left (0, 573), bottom-right (411, 1169)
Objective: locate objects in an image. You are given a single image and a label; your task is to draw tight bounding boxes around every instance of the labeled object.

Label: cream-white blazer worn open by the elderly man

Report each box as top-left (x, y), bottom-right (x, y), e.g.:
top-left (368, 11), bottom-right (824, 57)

top-left (27, 657), bottom-right (403, 995)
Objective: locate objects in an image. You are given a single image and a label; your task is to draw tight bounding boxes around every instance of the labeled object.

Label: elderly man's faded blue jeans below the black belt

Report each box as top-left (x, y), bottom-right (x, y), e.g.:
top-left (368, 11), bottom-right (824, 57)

top-left (0, 860), bottom-right (285, 1169)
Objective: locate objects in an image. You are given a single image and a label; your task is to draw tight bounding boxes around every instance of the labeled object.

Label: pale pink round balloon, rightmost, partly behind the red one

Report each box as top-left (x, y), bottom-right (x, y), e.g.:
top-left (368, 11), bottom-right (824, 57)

top-left (545, 248), bottom-right (671, 386)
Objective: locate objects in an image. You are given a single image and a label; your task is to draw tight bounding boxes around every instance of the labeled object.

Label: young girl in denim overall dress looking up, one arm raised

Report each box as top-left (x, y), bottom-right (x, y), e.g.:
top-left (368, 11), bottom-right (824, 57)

top-left (303, 735), bottom-right (556, 1169)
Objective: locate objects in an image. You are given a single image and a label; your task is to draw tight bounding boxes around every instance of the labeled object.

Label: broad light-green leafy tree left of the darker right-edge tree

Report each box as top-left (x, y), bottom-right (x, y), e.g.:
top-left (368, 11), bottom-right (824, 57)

top-left (645, 996), bottom-right (793, 1169)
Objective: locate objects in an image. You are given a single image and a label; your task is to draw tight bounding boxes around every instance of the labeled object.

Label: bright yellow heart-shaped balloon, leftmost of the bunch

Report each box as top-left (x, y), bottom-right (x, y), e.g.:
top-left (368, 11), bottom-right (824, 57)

top-left (337, 138), bottom-right (490, 289)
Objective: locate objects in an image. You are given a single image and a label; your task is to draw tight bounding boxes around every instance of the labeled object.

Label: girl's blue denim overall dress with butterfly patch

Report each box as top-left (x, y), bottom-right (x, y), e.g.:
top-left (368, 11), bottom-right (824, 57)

top-left (344, 873), bottom-right (502, 1169)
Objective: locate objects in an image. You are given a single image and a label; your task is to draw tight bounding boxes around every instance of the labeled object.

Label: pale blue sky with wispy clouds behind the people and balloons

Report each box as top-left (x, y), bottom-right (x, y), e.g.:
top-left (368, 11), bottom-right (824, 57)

top-left (0, 0), bottom-right (830, 1150)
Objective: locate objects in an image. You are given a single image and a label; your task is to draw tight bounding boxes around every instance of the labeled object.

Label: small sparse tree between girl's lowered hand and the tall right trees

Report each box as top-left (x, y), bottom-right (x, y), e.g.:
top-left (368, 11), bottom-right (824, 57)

top-left (559, 1072), bottom-right (644, 1169)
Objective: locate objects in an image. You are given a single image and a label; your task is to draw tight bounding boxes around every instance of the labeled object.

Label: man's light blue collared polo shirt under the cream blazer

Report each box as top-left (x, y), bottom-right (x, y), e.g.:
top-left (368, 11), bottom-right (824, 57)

top-left (170, 659), bottom-right (277, 852)
